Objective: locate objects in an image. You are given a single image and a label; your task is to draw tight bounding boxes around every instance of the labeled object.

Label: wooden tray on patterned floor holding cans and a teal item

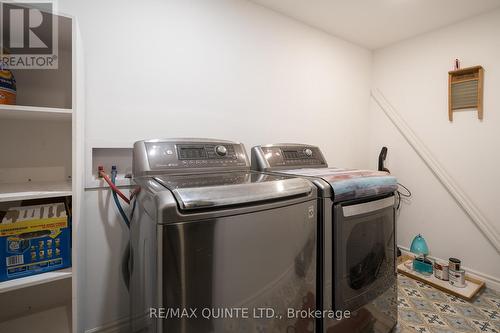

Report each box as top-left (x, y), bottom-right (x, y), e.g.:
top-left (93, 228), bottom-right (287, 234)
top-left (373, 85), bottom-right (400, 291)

top-left (398, 259), bottom-right (484, 302)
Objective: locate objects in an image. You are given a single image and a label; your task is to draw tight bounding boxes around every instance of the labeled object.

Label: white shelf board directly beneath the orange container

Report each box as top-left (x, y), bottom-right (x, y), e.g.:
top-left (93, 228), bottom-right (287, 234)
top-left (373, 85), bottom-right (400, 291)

top-left (0, 104), bottom-right (73, 121)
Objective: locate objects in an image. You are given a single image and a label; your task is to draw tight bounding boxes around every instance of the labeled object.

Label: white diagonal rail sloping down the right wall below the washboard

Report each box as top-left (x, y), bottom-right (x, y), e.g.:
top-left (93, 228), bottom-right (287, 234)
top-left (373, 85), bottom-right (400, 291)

top-left (371, 88), bottom-right (500, 253)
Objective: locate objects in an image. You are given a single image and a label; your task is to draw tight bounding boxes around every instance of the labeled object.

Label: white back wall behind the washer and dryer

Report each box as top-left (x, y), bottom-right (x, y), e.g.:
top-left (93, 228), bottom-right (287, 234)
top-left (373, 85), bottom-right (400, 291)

top-left (59, 0), bottom-right (371, 329)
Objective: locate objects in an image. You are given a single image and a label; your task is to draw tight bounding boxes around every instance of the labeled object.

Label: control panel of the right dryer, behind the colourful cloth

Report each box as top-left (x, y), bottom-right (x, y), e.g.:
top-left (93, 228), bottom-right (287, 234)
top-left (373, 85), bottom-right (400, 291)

top-left (252, 144), bottom-right (328, 171)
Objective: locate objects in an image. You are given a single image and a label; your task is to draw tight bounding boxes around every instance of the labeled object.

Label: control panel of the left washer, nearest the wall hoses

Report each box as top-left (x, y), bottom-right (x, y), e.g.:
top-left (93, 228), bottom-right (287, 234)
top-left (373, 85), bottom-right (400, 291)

top-left (132, 139), bottom-right (250, 176)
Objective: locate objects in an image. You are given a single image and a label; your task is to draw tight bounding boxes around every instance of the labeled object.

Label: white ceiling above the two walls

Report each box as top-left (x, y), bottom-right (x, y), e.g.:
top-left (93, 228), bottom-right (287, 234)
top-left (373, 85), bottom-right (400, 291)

top-left (252, 0), bottom-right (500, 49)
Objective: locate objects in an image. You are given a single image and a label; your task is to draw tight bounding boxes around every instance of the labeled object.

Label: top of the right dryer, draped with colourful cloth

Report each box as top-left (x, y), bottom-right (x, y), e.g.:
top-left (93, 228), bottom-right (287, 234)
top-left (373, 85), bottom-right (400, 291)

top-left (280, 168), bottom-right (398, 202)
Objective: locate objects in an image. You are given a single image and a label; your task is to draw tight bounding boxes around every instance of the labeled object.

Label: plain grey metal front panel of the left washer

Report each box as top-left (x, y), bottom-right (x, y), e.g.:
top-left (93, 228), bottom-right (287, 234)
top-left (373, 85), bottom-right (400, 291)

top-left (157, 200), bottom-right (316, 333)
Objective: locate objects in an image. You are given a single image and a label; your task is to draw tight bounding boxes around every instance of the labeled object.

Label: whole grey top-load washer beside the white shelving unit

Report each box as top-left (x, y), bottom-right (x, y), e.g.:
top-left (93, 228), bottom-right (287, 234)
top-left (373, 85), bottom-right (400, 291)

top-left (130, 139), bottom-right (317, 333)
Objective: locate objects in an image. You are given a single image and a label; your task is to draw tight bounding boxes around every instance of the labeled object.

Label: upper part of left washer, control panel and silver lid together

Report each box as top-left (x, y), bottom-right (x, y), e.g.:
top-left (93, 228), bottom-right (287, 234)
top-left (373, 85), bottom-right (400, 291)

top-left (132, 139), bottom-right (315, 210)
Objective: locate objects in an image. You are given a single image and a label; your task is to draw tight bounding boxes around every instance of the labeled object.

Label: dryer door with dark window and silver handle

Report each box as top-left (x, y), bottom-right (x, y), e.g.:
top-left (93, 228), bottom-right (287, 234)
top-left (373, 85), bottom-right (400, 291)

top-left (333, 196), bottom-right (396, 311)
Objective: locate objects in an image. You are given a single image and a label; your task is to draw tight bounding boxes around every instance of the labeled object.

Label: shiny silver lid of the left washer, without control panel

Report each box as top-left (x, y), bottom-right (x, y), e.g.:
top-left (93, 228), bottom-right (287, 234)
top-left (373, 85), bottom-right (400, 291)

top-left (154, 172), bottom-right (313, 210)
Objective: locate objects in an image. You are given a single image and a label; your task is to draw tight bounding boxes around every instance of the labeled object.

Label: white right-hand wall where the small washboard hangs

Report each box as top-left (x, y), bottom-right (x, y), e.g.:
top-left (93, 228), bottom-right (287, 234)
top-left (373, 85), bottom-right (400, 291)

top-left (370, 10), bottom-right (500, 288)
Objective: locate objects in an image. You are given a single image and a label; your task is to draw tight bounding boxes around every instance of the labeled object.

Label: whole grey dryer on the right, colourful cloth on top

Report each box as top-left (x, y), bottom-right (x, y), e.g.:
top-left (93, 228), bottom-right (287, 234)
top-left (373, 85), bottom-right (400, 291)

top-left (252, 144), bottom-right (397, 332)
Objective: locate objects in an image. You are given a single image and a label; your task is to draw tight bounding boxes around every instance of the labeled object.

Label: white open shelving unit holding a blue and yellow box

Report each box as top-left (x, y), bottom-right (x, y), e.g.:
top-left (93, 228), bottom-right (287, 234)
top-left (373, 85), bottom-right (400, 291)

top-left (0, 11), bottom-right (84, 331)
